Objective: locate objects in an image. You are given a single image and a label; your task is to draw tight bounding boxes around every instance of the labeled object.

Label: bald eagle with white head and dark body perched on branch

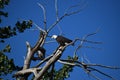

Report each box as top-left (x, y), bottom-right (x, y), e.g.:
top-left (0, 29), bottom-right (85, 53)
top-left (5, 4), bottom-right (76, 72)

top-left (51, 35), bottom-right (72, 46)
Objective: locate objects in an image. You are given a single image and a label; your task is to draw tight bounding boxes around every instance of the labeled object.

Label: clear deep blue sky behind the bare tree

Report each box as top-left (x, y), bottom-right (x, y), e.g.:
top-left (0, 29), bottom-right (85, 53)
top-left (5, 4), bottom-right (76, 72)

top-left (1, 0), bottom-right (120, 80)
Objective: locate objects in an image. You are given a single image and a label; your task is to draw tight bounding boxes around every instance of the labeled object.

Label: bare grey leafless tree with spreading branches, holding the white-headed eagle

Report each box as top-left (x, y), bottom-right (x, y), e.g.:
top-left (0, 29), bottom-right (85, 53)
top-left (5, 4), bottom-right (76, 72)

top-left (14, 0), bottom-right (120, 80)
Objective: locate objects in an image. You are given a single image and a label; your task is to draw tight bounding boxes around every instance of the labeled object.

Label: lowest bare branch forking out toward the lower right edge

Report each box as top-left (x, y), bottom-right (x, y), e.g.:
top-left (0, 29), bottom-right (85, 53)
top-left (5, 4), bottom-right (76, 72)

top-left (58, 59), bottom-right (120, 80)
